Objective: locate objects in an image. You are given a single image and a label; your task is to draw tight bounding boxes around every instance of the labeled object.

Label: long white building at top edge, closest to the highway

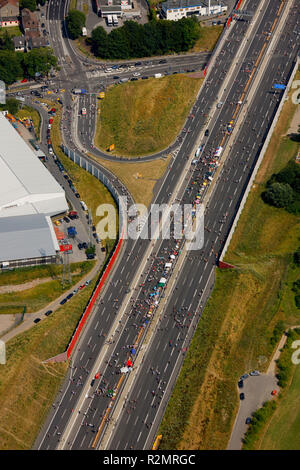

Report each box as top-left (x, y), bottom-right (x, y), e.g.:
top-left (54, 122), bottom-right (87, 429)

top-left (161, 0), bottom-right (227, 21)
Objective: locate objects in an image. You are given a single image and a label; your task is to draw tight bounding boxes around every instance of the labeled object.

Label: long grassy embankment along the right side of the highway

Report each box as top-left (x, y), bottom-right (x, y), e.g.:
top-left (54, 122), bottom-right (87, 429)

top-left (159, 71), bottom-right (300, 449)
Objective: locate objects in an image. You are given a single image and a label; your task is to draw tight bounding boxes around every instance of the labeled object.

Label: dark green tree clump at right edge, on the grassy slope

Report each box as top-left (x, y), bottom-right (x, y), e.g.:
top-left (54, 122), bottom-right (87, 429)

top-left (262, 161), bottom-right (300, 214)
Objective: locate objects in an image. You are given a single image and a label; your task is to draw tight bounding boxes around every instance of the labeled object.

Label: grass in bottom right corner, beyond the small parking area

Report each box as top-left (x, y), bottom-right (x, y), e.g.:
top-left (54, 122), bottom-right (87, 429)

top-left (243, 330), bottom-right (300, 450)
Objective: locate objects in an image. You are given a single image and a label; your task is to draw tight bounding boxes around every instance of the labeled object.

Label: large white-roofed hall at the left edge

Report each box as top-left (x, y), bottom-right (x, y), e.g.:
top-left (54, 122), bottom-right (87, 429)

top-left (0, 113), bottom-right (68, 267)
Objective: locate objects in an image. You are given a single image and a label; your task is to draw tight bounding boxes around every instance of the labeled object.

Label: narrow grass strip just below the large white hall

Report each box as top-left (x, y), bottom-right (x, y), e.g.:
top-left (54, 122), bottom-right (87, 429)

top-left (0, 261), bottom-right (95, 314)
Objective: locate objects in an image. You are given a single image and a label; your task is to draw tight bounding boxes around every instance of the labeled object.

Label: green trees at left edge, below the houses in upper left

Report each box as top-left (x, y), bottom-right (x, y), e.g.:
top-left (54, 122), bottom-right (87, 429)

top-left (0, 47), bottom-right (57, 85)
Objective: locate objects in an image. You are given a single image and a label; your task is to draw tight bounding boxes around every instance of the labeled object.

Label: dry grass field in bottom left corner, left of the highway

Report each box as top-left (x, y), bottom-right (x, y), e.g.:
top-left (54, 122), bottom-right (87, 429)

top-left (0, 281), bottom-right (95, 450)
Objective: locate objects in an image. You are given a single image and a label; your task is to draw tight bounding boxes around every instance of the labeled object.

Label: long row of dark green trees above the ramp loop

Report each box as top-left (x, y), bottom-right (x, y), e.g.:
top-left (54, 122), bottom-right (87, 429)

top-left (87, 18), bottom-right (200, 59)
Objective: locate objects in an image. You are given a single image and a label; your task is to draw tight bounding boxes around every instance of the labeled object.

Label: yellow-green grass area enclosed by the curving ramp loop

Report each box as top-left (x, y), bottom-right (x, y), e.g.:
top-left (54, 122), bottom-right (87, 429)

top-left (95, 74), bottom-right (203, 157)
